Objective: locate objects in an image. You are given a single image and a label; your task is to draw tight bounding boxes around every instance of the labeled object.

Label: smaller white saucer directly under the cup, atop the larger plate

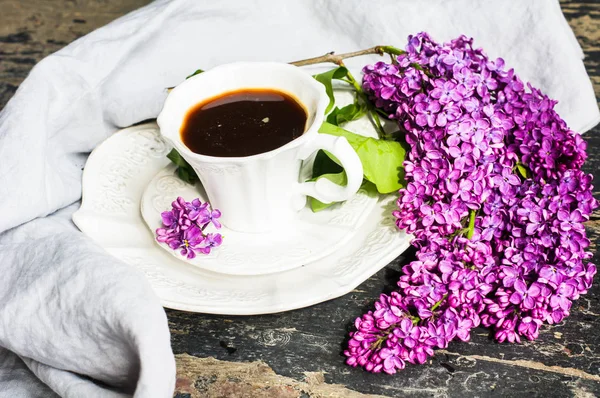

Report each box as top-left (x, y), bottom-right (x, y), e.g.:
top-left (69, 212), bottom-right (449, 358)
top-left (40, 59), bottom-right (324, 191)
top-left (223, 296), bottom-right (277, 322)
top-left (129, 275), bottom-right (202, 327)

top-left (141, 165), bottom-right (378, 275)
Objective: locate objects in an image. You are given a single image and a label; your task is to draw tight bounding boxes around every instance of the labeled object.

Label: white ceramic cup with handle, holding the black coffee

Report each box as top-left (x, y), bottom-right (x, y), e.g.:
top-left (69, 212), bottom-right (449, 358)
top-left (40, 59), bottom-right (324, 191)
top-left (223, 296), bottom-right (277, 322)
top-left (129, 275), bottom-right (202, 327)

top-left (157, 62), bottom-right (363, 233)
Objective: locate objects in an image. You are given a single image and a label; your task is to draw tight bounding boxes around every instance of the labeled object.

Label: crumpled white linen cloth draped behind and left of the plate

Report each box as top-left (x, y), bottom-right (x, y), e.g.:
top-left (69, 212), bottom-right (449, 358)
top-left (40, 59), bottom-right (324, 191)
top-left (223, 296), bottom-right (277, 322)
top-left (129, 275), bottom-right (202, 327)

top-left (0, 0), bottom-right (600, 398)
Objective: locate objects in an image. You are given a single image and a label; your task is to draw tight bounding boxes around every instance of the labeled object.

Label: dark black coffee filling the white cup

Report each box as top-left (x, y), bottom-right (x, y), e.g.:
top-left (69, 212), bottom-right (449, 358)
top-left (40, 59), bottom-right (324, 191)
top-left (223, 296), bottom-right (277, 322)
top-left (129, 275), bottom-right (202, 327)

top-left (181, 89), bottom-right (307, 157)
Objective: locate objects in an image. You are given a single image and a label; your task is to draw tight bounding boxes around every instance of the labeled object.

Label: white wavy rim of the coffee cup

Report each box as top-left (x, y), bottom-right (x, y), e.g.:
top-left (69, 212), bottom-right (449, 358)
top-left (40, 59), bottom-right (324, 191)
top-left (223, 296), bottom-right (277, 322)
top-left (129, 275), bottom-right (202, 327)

top-left (156, 61), bottom-right (329, 163)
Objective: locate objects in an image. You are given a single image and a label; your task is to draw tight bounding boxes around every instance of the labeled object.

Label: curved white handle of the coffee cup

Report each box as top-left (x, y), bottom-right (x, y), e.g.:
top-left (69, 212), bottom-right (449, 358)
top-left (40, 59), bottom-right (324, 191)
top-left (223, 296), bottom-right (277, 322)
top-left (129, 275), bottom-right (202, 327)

top-left (298, 134), bottom-right (363, 203)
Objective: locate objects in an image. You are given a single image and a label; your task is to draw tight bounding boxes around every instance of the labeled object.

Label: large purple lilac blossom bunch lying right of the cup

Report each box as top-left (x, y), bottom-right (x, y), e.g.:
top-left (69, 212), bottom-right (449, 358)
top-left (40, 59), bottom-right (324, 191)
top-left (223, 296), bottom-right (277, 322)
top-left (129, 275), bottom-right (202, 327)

top-left (345, 33), bottom-right (598, 374)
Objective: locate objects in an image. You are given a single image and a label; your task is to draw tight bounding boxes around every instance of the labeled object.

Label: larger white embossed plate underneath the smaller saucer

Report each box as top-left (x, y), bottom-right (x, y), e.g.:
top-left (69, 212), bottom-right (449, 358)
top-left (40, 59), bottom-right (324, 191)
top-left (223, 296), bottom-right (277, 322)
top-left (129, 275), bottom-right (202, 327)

top-left (73, 123), bottom-right (409, 315)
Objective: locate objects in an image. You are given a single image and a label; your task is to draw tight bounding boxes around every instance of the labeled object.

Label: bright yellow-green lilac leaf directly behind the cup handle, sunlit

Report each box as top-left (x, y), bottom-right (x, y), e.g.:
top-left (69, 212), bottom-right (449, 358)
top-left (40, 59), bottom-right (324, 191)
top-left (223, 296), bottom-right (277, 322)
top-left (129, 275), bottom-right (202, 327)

top-left (319, 122), bottom-right (406, 194)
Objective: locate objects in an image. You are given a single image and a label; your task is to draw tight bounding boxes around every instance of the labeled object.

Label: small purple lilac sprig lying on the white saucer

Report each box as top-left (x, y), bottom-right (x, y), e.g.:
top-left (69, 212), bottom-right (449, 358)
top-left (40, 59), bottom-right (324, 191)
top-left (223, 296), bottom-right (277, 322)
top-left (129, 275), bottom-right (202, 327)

top-left (156, 197), bottom-right (223, 259)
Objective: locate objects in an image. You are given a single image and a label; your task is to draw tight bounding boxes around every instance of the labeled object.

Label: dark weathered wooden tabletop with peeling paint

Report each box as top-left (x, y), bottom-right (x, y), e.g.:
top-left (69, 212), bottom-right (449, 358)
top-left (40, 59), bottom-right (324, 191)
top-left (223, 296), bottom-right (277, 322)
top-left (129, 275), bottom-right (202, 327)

top-left (0, 0), bottom-right (600, 398)
